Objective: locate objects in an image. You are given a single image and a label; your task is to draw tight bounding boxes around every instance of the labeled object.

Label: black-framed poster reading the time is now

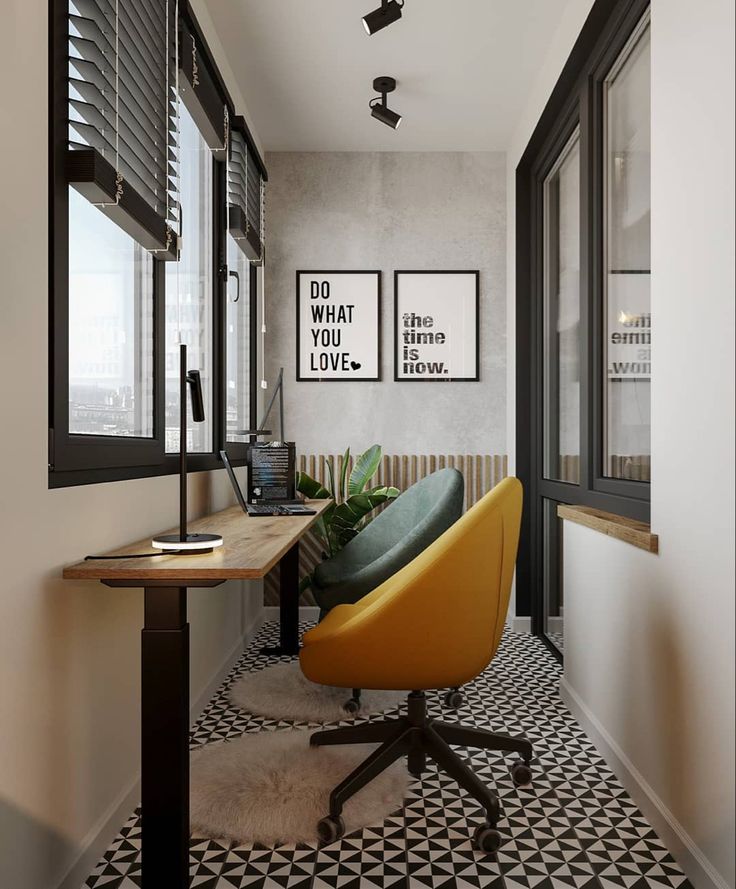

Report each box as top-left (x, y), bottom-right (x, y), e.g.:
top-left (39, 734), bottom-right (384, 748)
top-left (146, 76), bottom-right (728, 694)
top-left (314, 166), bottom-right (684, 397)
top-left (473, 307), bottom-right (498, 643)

top-left (394, 271), bottom-right (480, 383)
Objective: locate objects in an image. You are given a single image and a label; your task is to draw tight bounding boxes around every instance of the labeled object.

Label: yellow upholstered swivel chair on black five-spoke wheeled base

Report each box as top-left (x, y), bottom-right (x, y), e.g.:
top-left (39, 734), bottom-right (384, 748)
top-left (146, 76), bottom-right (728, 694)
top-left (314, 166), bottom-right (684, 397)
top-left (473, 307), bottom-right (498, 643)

top-left (300, 478), bottom-right (532, 852)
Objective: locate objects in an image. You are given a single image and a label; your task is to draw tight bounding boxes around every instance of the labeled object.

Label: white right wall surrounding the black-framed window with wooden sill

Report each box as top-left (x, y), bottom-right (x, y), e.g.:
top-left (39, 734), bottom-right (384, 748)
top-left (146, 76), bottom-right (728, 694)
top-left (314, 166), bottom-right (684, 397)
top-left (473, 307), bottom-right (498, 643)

top-left (508, 0), bottom-right (734, 887)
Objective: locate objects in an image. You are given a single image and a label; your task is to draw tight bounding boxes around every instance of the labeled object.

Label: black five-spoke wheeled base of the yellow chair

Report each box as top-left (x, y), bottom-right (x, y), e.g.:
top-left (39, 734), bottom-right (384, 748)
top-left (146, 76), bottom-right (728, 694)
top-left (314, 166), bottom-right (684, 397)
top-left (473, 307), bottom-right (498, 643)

top-left (310, 691), bottom-right (532, 852)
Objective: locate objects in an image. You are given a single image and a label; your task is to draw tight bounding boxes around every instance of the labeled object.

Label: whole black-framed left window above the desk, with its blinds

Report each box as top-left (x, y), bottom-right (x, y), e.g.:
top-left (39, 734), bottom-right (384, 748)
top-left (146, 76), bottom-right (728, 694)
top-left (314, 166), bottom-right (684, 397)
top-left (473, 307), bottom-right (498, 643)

top-left (49, 0), bottom-right (267, 487)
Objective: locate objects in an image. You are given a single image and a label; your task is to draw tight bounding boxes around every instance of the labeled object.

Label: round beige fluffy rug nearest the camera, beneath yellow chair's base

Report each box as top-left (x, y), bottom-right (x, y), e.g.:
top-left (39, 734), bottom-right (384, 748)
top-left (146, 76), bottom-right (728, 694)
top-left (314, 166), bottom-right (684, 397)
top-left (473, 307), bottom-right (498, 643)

top-left (191, 730), bottom-right (408, 846)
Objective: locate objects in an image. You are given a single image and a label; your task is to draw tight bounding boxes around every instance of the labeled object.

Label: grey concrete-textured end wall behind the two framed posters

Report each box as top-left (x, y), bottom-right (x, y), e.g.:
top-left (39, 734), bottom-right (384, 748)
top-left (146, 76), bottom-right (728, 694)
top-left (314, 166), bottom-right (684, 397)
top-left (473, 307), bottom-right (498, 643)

top-left (266, 152), bottom-right (506, 454)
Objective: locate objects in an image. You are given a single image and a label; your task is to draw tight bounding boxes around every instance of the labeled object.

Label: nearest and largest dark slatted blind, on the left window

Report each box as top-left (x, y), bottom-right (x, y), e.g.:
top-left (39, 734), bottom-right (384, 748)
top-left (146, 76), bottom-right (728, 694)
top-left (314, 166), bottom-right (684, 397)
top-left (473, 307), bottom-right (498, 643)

top-left (66, 0), bottom-right (178, 259)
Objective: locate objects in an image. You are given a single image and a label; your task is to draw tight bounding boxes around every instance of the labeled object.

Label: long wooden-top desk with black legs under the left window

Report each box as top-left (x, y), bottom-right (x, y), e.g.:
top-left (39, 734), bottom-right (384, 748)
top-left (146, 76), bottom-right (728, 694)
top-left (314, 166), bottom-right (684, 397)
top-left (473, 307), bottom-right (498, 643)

top-left (63, 500), bottom-right (330, 889)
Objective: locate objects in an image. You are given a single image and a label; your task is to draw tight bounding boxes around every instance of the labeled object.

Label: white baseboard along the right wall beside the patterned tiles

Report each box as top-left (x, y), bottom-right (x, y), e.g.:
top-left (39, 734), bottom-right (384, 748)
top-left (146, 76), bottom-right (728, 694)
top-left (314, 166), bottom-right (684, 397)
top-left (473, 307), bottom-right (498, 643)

top-left (560, 679), bottom-right (729, 889)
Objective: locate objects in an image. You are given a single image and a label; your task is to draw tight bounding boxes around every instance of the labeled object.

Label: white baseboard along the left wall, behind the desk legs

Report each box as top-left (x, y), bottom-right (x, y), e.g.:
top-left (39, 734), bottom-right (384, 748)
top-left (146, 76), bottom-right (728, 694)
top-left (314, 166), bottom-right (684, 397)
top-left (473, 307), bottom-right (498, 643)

top-left (56, 609), bottom-right (268, 889)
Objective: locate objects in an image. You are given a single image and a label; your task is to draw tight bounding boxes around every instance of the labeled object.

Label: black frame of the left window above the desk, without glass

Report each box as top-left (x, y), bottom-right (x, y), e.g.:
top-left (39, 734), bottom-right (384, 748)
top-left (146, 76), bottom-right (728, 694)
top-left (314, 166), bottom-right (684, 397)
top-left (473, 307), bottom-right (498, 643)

top-left (48, 0), bottom-right (267, 488)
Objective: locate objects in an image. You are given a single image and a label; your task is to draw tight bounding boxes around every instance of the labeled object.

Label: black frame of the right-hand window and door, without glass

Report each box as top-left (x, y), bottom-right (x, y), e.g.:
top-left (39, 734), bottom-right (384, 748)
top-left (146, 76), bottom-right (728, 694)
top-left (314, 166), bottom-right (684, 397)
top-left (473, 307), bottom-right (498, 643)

top-left (515, 0), bottom-right (650, 640)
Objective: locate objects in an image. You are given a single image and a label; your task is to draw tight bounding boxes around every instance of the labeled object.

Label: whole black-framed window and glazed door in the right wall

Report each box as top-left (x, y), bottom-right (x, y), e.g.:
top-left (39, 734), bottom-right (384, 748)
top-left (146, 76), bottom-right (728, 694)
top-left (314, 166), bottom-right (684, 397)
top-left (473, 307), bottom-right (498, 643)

top-left (516, 0), bottom-right (656, 656)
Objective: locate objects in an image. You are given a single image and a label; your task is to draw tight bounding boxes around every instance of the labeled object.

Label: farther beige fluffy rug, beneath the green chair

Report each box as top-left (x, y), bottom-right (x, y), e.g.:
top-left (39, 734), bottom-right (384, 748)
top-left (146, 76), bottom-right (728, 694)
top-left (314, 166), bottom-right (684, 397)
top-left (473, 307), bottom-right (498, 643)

top-left (230, 661), bottom-right (406, 723)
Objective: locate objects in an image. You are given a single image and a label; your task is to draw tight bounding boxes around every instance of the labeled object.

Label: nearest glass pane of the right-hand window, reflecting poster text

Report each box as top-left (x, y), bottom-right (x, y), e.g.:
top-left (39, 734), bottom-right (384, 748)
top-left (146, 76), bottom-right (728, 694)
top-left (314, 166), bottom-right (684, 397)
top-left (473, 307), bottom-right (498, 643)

top-left (603, 17), bottom-right (652, 481)
